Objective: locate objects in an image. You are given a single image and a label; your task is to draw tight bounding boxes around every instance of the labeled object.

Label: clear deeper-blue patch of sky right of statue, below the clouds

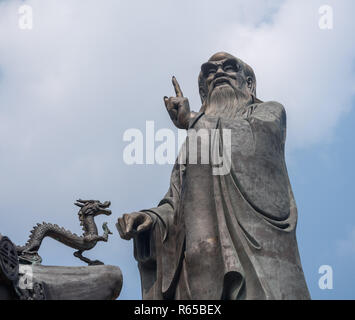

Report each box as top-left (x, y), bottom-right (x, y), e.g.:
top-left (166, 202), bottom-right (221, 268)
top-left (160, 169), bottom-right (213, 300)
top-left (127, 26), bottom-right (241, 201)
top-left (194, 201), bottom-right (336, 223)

top-left (288, 105), bottom-right (355, 299)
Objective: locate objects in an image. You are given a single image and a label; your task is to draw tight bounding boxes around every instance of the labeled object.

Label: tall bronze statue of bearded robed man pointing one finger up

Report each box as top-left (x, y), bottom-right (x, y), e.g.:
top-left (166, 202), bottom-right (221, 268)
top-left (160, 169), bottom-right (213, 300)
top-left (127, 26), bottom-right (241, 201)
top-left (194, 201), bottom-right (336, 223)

top-left (116, 52), bottom-right (310, 300)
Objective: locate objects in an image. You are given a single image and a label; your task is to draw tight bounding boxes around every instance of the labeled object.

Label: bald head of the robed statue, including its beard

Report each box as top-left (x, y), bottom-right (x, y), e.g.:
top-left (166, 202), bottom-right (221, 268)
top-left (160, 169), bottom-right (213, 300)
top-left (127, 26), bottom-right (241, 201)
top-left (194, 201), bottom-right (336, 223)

top-left (198, 52), bottom-right (256, 117)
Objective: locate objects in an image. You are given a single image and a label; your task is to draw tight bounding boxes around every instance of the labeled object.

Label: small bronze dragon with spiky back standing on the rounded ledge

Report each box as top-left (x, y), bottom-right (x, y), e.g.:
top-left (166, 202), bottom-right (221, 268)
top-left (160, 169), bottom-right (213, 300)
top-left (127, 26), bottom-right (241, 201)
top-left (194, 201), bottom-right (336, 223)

top-left (16, 199), bottom-right (112, 265)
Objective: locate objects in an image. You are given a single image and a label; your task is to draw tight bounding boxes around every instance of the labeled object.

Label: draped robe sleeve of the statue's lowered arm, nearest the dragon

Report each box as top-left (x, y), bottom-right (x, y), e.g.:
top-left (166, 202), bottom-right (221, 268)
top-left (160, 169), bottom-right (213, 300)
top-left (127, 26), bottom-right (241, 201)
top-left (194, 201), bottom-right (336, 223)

top-left (134, 161), bottom-right (185, 300)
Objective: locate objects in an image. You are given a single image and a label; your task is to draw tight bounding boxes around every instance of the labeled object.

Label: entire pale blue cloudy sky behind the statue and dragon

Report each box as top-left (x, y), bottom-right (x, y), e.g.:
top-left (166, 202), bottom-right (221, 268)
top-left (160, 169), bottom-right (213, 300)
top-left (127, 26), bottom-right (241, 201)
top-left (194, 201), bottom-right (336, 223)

top-left (0, 0), bottom-right (355, 299)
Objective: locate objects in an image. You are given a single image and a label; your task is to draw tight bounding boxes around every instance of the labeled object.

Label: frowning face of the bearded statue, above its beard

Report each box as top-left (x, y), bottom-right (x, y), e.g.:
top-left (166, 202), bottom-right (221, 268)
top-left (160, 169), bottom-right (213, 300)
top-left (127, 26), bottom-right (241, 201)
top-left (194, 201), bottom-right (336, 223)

top-left (201, 56), bottom-right (248, 96)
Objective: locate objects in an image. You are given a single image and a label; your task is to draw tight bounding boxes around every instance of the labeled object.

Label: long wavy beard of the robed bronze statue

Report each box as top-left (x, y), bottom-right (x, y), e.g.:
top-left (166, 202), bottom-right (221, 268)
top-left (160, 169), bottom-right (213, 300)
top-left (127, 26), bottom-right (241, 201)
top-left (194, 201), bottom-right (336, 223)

top-left (205, 86), bottom-right (251, 119)
